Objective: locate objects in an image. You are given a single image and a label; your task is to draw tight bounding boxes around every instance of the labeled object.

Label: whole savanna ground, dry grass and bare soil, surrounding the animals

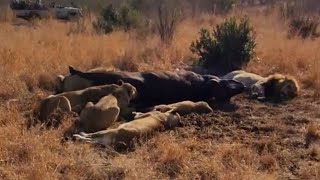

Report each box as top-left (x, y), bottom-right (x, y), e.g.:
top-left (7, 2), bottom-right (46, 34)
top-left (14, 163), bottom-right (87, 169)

top-left (0, 4), bottom-right (320, 179)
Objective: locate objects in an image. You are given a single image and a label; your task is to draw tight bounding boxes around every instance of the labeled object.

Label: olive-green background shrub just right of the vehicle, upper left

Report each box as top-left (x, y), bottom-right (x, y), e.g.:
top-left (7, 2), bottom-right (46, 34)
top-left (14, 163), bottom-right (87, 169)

top-left (93, 4), bottom-right (143, 33)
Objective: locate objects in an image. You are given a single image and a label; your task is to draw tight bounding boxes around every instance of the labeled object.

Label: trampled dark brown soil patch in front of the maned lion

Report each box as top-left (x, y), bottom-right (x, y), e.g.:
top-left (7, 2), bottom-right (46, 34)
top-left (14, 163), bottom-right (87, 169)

top-left (176, 91), bottom-right (320, 179)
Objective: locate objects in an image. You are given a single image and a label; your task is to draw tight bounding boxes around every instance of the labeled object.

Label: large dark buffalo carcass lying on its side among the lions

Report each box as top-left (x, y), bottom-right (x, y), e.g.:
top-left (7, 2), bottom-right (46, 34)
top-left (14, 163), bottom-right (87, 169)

top-left (58, 66), bottom-right (245, 108)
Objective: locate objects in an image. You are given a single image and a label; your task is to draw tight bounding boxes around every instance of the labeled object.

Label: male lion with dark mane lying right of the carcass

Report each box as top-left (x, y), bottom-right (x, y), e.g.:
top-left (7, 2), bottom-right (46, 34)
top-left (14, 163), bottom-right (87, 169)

top-left (222, 70), bottom-right (300, 101)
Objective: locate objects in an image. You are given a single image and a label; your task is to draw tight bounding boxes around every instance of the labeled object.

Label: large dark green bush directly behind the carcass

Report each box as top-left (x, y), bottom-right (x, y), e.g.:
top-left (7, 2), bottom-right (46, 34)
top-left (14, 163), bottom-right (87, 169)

top-left (190, 18), bottom-right (256, 73)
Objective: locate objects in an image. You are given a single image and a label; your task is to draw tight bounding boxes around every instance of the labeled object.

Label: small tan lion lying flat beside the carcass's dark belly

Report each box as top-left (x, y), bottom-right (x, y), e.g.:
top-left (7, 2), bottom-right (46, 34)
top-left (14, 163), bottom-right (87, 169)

top-left (152, 101), bottom-right (213, 116)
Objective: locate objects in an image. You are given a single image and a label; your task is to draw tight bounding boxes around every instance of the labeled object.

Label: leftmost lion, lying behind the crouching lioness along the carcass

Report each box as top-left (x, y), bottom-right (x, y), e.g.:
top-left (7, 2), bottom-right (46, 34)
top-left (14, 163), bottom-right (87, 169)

top-left (39, 81), bottom-right (135, 120)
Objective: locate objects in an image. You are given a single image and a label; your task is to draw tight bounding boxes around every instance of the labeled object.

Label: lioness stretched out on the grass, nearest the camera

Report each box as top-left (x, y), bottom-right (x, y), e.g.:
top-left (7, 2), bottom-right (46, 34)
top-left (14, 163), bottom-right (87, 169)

top-left (73, 111), bottom-right (181, 146)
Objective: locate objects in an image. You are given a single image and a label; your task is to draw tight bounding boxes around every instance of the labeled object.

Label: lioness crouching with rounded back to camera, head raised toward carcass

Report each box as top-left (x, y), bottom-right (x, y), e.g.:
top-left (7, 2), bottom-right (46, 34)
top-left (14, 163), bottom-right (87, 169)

top-left (78, 83), bottom-right (136, 133)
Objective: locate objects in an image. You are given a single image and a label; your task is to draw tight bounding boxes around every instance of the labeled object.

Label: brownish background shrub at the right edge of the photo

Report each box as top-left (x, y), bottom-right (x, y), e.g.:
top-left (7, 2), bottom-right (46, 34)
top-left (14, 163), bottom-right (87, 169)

top-left (289, 16), bottom-right (319, 39)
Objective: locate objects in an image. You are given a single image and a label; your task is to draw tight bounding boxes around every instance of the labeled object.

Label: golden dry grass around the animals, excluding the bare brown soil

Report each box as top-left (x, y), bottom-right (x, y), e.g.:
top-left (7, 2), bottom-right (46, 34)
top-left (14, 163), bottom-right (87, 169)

top-left (0, 7), bottom-right (320, 179)
